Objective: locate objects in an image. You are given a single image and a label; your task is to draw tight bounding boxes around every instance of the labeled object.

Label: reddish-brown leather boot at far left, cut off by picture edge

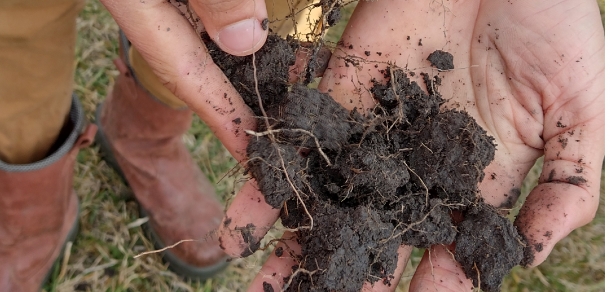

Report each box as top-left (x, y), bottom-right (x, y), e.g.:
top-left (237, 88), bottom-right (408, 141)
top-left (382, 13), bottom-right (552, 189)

top-left (0, 98), bottom-right (96, 292)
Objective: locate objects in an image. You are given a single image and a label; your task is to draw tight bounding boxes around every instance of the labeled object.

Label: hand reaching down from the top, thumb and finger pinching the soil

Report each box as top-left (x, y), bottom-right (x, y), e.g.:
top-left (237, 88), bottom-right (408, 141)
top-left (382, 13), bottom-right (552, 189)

top-left (101, 0), bottom-right (267, 160)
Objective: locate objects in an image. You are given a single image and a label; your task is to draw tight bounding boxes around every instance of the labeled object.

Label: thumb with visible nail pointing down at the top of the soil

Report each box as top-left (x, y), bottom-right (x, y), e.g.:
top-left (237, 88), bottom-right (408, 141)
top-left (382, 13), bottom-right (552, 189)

top-left (191, 0), bottom-right (268, 56)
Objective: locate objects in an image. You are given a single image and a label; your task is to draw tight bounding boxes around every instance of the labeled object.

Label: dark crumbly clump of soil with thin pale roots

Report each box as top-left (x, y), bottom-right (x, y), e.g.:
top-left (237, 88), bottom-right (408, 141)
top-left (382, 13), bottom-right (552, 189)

top-left (203, 35), bottom-right (523, 291)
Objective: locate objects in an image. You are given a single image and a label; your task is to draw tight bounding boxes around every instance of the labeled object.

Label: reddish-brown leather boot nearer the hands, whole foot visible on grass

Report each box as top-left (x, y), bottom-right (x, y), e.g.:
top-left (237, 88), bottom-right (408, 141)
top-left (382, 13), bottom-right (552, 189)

top-left (96, 49), bottom-right (227, 280)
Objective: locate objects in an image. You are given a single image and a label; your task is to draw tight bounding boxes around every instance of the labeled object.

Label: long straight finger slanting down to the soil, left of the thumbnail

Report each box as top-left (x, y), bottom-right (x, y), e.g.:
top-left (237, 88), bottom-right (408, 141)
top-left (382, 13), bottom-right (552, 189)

top-left (102, 0), bottom-right (255, 161)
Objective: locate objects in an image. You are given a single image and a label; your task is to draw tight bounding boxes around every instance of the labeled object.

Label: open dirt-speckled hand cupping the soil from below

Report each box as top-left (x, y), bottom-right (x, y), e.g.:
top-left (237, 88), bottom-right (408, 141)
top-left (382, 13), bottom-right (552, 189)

top-left (216, 0), bottom-right (604, 291)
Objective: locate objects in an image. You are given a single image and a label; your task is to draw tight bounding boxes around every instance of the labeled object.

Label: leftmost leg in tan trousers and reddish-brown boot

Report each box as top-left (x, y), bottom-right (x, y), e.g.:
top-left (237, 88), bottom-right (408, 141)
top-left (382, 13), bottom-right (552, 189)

top-left (0, 0), bottom-right (95, 292)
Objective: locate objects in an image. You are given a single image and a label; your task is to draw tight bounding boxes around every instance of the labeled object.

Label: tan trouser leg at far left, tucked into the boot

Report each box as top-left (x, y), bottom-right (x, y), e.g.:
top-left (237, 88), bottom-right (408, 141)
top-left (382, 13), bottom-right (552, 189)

top-left (0, 0), bottom-right (82, 164)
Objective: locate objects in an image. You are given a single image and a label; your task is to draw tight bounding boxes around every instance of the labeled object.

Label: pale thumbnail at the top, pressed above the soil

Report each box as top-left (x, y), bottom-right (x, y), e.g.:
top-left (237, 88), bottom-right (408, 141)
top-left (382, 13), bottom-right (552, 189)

top-left (216, 18), bottom-right (266, 55)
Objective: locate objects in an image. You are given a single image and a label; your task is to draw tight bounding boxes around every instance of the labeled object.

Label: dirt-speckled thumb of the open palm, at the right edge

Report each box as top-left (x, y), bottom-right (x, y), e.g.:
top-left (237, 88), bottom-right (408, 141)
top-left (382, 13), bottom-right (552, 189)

top-left (515, 58), bottom-right (604, 266)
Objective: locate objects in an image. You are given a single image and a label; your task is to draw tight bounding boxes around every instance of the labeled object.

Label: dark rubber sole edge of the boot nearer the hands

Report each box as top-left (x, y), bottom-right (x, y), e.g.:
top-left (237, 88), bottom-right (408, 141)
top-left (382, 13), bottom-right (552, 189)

top-left (95, 104), bottom-right (229, 281)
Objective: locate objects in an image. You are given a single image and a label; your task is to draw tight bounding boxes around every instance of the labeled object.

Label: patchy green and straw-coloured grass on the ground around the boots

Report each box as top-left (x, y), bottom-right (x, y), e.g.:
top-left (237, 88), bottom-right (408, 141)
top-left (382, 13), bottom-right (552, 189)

top-left (45, 0), bottom-right (605, 292)
